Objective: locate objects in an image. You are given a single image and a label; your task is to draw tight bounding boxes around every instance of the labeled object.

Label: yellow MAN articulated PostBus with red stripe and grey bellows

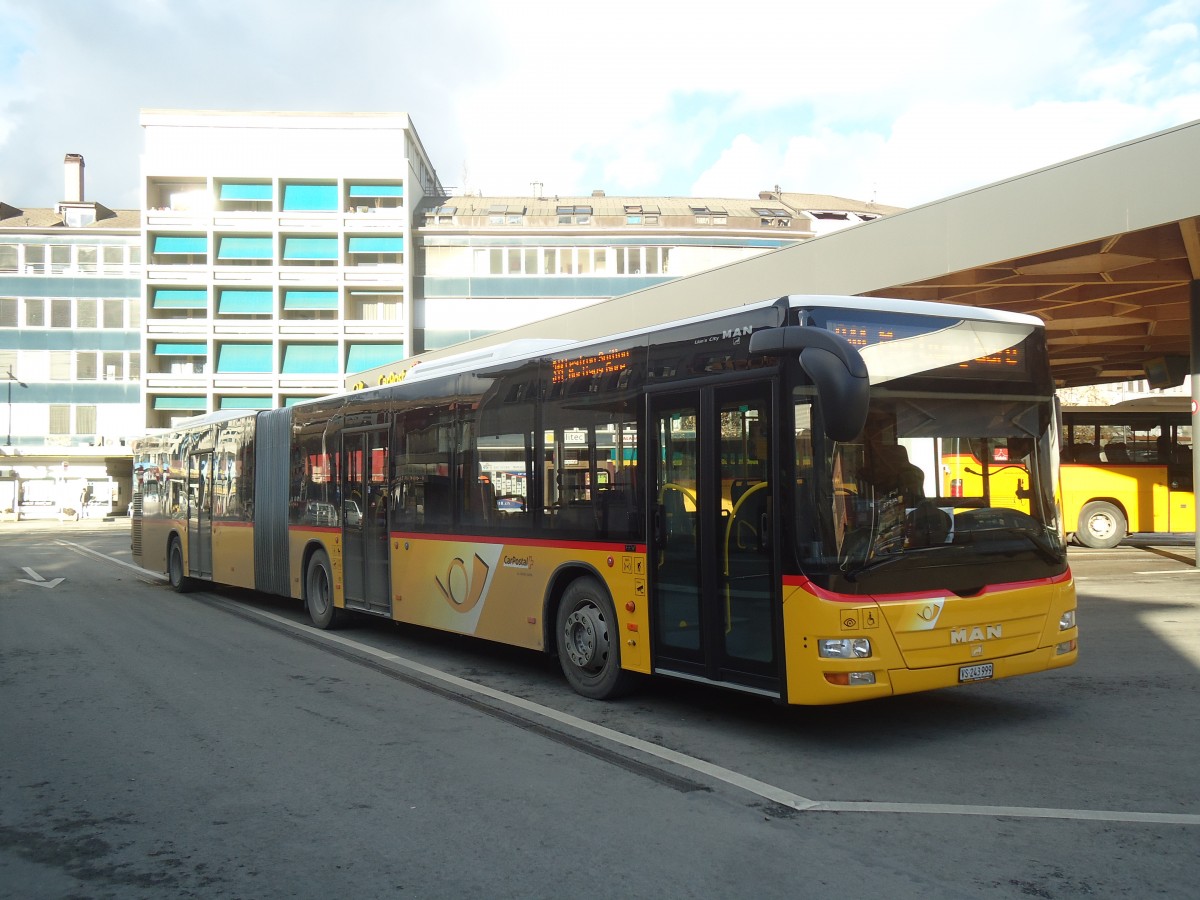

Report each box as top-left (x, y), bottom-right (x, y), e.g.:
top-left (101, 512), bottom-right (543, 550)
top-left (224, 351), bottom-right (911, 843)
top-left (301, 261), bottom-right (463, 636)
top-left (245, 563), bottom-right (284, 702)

top-left (133, 296), bottom-right (1078, 704)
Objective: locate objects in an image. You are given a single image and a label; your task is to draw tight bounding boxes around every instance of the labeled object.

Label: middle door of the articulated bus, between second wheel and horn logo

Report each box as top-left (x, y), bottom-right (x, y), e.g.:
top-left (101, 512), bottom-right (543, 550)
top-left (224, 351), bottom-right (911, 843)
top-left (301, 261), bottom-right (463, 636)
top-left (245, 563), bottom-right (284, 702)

top-left (341, 428), bottom-right (391, 616)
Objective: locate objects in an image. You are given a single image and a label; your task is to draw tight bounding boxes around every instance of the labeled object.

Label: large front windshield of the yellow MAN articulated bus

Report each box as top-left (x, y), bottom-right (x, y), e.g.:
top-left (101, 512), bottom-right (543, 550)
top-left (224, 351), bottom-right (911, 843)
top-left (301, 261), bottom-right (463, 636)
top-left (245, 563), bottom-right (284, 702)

top-left (794, 396), bottom-right (1066, 593)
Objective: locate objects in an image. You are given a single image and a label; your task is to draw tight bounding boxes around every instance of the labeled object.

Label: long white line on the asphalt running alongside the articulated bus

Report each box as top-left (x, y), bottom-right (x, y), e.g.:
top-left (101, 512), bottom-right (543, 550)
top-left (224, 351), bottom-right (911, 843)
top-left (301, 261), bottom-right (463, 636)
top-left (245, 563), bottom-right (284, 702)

top-left (58, 541), bottom-right (1200, 826)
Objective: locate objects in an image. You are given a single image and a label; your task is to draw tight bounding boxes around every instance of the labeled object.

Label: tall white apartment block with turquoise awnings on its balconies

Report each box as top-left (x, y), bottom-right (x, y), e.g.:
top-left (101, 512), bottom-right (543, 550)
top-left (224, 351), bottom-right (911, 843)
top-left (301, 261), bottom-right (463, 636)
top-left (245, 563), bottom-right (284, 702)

top-left (140, 110), bottom-right (444, 427)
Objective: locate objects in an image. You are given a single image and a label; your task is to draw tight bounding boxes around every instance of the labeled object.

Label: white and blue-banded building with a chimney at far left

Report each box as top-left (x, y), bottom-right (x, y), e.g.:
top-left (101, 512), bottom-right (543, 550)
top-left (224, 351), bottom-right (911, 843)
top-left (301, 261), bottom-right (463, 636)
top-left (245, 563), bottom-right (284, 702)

top-left (0, 154), bottom-right (144, 517)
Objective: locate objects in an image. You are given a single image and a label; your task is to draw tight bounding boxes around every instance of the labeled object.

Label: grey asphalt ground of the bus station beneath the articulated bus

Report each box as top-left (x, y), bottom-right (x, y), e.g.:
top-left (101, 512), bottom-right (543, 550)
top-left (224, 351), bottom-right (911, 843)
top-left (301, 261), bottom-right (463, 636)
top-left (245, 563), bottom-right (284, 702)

top-left (0, 524), bottom-right (1200, 899)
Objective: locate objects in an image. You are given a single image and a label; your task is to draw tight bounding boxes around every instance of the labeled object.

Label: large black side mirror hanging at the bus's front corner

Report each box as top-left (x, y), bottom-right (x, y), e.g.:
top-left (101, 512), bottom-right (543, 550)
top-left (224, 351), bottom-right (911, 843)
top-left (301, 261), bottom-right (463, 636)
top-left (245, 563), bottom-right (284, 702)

top-left (750, 325), bottom-right (871, 443)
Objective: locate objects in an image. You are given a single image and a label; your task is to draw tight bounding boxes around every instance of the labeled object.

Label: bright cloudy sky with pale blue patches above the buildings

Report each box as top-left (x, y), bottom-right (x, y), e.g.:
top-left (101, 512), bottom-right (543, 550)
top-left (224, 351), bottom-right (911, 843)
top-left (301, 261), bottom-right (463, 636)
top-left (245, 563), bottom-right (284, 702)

top-left (0, 0), bottom-right (1200, 209)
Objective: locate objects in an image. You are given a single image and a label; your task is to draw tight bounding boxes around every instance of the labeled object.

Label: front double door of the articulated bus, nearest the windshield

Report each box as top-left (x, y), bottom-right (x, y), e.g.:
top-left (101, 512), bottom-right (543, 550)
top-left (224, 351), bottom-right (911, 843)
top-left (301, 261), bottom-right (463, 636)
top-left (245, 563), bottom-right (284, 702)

top-left (649, 382), bottom-right (781, 696)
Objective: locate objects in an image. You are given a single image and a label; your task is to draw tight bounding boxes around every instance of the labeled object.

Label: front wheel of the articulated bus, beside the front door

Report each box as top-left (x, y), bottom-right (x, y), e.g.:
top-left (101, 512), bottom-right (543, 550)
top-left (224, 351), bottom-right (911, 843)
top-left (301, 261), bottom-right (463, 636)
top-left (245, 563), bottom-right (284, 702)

top-left (554, 577), bottom-right (637, 700)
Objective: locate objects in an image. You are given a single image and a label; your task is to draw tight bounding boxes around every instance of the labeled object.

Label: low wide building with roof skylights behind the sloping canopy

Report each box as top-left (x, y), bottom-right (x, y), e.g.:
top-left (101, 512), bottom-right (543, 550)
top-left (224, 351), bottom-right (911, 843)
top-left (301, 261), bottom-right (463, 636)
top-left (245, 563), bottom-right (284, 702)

top-left (412, 187), bottom-right (896, 353)
